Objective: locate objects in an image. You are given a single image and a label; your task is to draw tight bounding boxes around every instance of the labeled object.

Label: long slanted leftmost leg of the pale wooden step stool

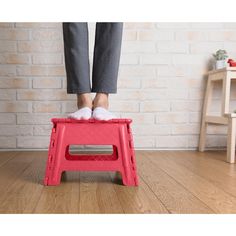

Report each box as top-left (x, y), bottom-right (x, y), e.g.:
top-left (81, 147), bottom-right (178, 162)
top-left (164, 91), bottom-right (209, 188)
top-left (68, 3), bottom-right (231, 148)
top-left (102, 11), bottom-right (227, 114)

top-left (199, 75), bottom-right (213, 152)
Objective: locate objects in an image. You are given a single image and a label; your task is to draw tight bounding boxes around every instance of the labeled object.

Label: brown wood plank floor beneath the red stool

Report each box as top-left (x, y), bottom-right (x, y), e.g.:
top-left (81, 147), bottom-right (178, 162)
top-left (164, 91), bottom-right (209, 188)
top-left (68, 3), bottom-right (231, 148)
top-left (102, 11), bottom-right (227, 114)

top-left (0, 151), bottom-right (236, 214)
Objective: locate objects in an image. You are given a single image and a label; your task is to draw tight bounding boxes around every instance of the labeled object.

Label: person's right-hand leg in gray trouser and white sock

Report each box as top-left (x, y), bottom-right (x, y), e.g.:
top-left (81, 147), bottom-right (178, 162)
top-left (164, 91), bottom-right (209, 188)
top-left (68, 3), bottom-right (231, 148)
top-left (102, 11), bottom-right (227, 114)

top-left (92, 22), bottom-right (123, 119)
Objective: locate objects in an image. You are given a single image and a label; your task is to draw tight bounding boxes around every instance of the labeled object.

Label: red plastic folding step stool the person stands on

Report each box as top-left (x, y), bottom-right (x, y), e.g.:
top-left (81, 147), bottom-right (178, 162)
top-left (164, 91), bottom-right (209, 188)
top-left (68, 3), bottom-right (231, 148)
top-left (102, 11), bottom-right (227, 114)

top-left (44, 118), bottom-right (138, 186)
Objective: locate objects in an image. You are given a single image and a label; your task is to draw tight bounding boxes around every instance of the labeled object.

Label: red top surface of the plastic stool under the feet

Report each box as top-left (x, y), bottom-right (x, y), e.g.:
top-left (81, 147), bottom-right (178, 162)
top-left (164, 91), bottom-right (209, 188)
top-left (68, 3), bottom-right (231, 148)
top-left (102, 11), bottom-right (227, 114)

top-left (51, 118), bottom-right (132, 124)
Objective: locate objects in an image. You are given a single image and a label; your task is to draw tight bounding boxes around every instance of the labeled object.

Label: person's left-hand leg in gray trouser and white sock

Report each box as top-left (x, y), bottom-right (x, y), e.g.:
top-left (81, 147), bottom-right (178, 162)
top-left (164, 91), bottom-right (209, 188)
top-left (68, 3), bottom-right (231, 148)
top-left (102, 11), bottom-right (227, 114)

top-left (62, 22), bottom-right (92, 119)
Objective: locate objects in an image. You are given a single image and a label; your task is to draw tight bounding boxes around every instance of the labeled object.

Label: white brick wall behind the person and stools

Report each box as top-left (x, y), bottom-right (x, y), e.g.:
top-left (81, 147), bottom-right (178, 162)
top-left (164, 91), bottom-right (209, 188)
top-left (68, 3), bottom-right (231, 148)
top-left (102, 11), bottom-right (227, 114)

top-left (0, 22), bottom-right (236, 149)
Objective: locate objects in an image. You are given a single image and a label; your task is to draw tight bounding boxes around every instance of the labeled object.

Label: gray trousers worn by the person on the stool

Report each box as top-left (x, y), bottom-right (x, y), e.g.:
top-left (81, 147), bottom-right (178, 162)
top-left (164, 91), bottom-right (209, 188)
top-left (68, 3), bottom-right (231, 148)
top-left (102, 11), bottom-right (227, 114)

top-left (62, 22), bottom-right (123, 94)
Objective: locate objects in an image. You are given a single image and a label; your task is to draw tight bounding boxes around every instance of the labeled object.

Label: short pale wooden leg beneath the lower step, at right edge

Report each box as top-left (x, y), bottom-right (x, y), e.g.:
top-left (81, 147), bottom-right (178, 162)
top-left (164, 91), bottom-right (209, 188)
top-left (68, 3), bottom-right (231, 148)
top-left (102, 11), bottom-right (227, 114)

top-left (227, 118), bottom-right (236, 163)
